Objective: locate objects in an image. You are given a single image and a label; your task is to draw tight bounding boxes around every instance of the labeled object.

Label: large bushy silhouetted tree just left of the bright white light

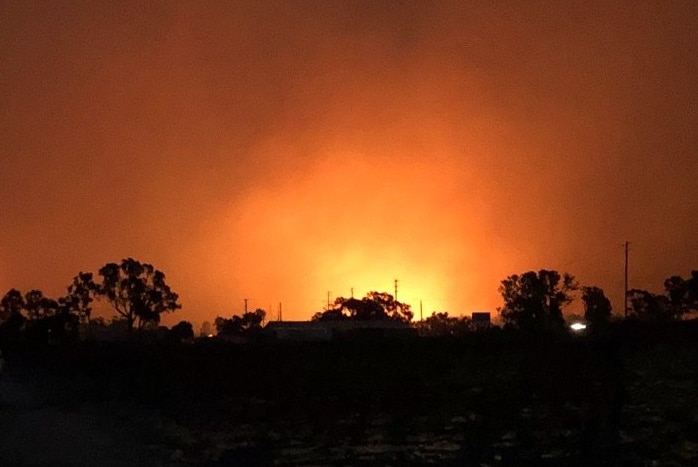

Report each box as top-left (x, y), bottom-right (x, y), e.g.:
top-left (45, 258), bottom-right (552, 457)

top-left (499, 269), bottom-right (578, 332)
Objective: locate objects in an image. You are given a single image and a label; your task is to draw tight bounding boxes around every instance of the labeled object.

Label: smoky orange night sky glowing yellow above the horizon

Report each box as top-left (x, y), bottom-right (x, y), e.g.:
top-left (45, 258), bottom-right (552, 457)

top-left (0, 0), bottom-right (698, 324)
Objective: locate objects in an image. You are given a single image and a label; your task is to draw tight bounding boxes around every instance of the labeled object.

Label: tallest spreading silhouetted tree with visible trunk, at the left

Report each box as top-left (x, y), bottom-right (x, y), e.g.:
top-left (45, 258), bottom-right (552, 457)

top-left (97, 258), bottom-right (181, 331)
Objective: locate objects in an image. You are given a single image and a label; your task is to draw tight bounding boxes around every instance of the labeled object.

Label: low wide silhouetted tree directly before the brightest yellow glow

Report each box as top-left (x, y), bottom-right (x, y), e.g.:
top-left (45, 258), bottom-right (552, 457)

top-left (312, 292), bottom-right (413, 322)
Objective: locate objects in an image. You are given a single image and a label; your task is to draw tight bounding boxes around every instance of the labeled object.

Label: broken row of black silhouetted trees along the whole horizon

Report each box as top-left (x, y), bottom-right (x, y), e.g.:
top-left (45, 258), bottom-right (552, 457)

top-left (0, 258), bottom-right (698, 347)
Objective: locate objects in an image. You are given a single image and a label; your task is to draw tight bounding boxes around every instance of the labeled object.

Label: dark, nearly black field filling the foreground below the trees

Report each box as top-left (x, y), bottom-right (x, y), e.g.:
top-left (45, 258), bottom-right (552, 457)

top-left (0, 328), bottom-right (698, 466)
